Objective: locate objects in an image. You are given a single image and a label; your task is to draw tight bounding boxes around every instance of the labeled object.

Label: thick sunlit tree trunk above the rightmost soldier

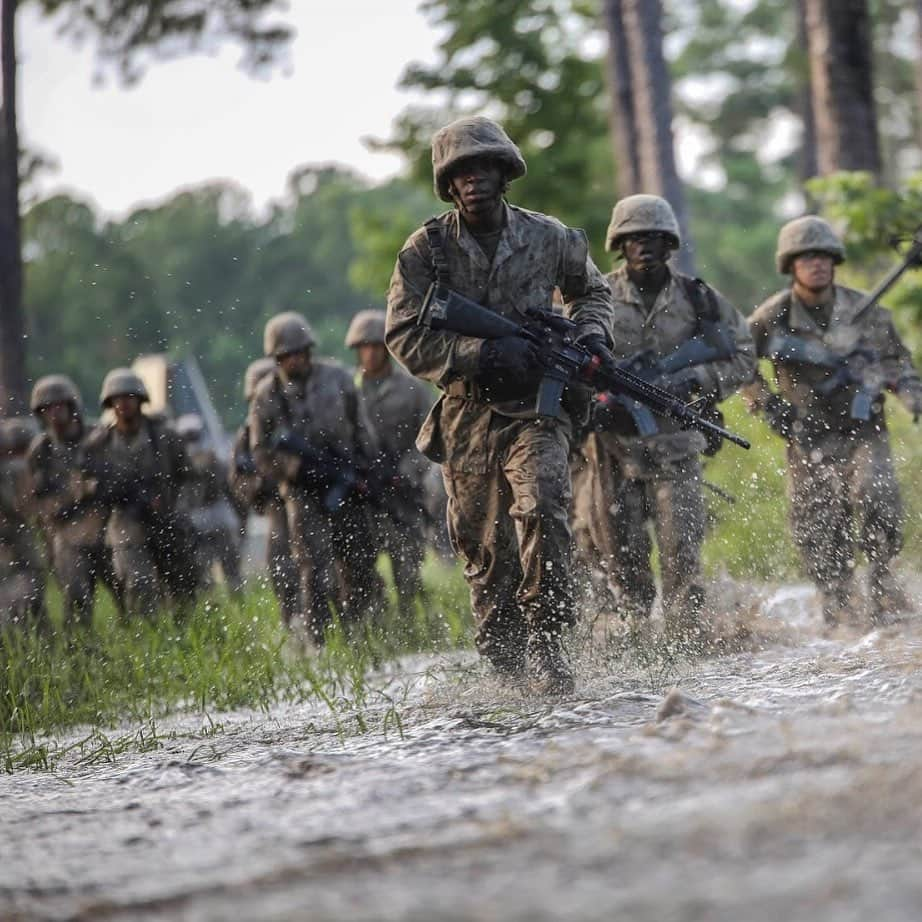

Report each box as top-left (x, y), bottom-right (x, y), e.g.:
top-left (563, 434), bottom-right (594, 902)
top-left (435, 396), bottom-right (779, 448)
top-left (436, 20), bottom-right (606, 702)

top-left (806, 0), bottom-right (881, 176)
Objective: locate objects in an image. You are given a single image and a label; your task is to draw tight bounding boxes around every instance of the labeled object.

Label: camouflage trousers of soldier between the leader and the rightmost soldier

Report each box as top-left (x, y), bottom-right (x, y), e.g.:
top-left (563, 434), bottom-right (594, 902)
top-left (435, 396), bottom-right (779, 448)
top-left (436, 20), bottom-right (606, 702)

top-left (578, 439), bottom-right (706, 625)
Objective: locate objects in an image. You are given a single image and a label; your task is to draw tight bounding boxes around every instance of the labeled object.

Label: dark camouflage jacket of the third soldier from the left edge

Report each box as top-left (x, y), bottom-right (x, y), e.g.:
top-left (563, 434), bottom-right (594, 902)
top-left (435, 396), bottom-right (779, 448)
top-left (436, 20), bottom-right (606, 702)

top-left (85, 416), bottom-right (190, 546)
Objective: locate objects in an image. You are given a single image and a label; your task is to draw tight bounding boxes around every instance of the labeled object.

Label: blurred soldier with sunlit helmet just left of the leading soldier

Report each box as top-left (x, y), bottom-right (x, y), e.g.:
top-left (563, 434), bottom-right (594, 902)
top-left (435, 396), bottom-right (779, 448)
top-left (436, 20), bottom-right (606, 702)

top-left (346, 310), bottom-right (433, 625)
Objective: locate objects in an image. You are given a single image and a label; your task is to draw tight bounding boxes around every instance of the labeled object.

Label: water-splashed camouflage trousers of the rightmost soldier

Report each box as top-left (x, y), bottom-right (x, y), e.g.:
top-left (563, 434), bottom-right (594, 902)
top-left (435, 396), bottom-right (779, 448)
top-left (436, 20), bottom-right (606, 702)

top-left (788, 436), bottom-right (903, 608)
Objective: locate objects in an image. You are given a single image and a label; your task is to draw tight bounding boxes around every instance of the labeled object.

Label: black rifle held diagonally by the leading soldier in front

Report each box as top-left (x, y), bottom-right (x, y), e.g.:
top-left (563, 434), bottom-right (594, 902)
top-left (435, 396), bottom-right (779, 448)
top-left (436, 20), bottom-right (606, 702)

top-left (418, 283), bottom-right (750, 448)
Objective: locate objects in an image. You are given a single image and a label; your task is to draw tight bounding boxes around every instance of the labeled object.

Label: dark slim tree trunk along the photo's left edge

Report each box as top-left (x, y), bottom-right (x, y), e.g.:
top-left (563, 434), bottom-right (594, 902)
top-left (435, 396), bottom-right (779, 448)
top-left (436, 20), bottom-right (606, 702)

top-left (0, 0), bottom-right (26, 417)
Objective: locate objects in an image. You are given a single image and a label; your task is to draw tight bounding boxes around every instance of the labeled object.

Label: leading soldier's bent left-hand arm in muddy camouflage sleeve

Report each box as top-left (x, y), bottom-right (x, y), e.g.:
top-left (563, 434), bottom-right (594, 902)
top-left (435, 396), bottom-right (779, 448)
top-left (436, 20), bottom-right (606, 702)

top-left (385, 233), bottom-right (483, 387)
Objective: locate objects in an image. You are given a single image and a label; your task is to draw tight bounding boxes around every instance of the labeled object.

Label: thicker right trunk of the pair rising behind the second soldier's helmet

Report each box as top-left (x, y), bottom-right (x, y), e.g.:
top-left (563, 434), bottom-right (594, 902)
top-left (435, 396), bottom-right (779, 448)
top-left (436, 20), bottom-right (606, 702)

top-left (605, 0), bottom-right (695, 273)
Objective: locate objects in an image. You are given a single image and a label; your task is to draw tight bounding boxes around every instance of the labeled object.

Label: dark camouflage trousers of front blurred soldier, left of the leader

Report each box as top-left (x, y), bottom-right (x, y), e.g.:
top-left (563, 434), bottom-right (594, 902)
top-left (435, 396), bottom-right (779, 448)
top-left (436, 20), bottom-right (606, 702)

top-left (285, 488), bottom-right (384, 642)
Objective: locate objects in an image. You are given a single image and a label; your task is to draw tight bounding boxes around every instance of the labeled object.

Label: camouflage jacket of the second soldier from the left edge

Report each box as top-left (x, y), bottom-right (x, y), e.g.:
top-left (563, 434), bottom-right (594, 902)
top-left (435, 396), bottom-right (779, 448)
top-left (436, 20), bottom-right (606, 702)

top-left (26, 431), bottom-right (108, 546)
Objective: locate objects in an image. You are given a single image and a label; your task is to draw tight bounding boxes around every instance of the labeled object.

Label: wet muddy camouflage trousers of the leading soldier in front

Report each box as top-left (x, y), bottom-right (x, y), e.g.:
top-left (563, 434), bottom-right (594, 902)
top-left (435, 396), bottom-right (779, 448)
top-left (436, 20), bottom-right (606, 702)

top-left (442, 414), bottom-right (573, 665)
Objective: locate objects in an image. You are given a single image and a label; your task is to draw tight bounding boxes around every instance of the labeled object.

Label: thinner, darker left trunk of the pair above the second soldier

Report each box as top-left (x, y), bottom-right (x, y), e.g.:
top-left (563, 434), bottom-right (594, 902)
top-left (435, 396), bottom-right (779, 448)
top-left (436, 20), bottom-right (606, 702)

top-left (602, 0), bottom-right (636, 198)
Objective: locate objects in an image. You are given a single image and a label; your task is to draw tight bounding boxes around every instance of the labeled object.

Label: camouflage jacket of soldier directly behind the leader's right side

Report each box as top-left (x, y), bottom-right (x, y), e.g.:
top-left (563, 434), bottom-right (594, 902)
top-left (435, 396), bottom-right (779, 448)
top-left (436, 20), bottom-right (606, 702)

top-left (601, 266), bottom-right (755, 469)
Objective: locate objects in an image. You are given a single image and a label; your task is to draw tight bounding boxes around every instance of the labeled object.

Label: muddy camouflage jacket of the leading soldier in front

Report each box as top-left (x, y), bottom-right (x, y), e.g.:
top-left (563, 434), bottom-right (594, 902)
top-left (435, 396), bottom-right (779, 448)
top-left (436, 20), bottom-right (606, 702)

top-left (386, 205), bottom-right (611, 473)
